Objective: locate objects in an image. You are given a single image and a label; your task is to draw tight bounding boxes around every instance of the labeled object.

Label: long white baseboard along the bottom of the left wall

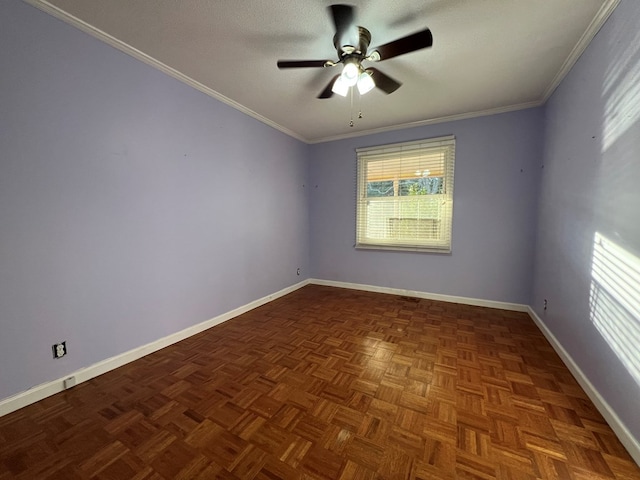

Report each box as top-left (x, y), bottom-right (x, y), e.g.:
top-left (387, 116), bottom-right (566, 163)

top-left (0, 280), bottom-right (309, 417)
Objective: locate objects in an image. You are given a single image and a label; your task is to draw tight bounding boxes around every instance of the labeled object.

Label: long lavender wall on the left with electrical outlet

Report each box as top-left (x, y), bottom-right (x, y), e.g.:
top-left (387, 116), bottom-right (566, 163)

top-left (0, 0), bottom-right (309, 399)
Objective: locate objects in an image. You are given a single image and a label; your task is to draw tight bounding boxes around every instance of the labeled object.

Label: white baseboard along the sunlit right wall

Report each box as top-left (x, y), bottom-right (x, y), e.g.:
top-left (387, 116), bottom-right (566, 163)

top-left (528, 307), bottom-right (640, 465)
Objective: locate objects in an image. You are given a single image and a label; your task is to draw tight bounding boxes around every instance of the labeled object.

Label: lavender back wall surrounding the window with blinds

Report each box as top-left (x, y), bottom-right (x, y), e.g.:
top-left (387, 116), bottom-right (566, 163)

top-left (310, 109), bottom-right (543, 304)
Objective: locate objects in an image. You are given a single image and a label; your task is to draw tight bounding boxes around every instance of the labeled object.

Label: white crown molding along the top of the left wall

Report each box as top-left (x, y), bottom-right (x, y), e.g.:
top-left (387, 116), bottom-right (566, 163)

top-left (23, 0), bottom-right (308, 143)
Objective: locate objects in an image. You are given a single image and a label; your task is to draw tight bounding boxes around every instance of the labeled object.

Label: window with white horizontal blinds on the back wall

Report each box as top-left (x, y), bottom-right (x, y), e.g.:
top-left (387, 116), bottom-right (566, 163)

top-left (356, 136), bottom-right (455, 253)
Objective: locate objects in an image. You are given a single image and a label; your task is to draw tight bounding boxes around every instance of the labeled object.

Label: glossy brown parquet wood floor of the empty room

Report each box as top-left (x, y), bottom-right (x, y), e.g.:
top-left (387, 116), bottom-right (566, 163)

top-left (0, 286), bottom-right (640, 480)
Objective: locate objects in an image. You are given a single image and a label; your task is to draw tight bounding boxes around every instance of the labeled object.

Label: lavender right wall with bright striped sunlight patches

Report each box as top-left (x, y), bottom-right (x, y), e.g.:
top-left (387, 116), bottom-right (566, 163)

top-left (532, 0), bottom-right (640, 439)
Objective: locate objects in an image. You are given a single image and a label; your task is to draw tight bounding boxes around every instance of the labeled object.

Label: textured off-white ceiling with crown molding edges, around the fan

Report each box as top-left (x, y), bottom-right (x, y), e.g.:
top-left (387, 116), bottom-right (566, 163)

top-left (26, 0), bottom-right (617, 143)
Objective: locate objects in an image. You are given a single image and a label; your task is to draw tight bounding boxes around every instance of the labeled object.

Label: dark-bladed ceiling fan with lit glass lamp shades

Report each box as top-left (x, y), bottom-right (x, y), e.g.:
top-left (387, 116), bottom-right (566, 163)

top-left (278, 5), bottom-right (433, 98)
